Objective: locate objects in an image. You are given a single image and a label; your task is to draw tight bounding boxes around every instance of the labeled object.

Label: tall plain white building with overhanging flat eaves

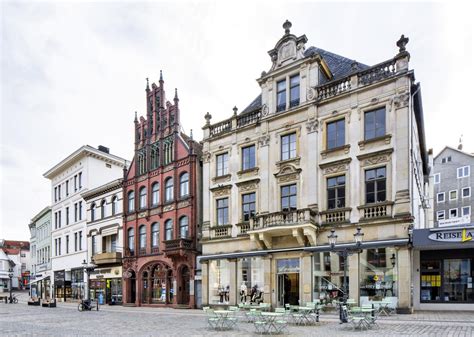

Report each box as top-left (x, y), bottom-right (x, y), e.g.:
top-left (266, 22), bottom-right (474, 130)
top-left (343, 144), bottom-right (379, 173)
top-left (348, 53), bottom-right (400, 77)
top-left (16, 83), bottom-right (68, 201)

top-left (44, 145), bottom-right (125, 301)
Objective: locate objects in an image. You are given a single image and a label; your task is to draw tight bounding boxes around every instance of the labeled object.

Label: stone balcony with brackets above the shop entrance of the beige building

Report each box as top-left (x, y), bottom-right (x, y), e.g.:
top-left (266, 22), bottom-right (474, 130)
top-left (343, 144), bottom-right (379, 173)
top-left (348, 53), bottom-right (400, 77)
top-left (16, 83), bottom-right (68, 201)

top-left (246, 208), bottom-right (318, 249)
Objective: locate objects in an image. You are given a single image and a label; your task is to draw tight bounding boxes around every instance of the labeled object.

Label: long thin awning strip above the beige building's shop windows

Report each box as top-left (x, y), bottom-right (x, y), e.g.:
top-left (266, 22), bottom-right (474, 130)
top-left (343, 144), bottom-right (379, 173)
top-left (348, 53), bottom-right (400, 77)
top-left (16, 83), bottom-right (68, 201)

top-left (198, 238), bottom-right (408, 262)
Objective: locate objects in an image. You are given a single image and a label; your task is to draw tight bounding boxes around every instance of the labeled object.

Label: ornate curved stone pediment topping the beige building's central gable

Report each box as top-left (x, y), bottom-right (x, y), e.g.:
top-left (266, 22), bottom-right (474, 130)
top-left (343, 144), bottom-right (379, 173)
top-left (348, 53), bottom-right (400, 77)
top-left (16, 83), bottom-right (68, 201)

top-left (268, 20), bottom-right (308, 71)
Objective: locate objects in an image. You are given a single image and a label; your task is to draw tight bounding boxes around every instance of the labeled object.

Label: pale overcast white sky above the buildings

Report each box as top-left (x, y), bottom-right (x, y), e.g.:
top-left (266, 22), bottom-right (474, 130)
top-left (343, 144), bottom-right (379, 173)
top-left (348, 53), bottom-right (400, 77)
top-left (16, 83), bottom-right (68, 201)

top-left (0, 1), bottom-right (474, 240)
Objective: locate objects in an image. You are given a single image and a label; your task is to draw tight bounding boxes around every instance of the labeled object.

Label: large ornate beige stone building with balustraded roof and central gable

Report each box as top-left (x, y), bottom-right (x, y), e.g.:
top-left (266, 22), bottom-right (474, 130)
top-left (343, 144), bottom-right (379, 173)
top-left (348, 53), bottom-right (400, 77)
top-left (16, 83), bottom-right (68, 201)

top-left (200, 21), bottom-right (428, 312)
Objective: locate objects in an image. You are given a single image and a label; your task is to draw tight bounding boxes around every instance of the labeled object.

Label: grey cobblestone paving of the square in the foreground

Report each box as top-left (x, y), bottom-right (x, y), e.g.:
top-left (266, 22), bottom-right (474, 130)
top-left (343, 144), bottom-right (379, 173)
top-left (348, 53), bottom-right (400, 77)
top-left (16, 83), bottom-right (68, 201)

top-left (0, 290), bottom-right (474, 337)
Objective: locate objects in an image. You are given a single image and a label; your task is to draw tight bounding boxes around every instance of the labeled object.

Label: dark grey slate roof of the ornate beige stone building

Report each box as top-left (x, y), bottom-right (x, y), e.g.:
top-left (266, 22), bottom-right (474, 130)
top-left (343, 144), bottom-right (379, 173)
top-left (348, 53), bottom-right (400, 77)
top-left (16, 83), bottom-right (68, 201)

top-left (241, 47), bottom-right (370, 113)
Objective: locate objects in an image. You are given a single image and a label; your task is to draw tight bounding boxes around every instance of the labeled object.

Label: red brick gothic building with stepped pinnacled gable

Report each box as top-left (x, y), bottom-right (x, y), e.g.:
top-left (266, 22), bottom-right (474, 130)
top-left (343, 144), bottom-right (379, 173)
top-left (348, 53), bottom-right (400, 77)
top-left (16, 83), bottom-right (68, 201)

top-left (123, 74), bottom-right (201, 307)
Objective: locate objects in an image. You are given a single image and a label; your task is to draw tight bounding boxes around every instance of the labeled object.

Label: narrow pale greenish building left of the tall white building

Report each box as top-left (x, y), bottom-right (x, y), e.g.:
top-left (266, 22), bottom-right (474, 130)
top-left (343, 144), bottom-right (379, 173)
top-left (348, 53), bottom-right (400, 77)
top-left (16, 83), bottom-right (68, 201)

top-left (29, 206), bottom-right (52, 299)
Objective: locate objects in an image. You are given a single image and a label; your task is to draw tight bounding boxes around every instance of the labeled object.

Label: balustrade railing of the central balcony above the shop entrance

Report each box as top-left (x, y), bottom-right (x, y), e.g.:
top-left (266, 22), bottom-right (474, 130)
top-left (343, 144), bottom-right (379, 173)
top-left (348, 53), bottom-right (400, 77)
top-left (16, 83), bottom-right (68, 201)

top-left (250, 208), bottom-right (317, 230)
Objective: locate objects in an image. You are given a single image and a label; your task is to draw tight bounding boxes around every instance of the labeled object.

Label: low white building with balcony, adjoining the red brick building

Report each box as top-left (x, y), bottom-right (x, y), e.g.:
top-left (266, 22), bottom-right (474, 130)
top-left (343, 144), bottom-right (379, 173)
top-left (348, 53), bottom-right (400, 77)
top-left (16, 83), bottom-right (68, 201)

top-left (82, 177), bottom-right (128, 304)
